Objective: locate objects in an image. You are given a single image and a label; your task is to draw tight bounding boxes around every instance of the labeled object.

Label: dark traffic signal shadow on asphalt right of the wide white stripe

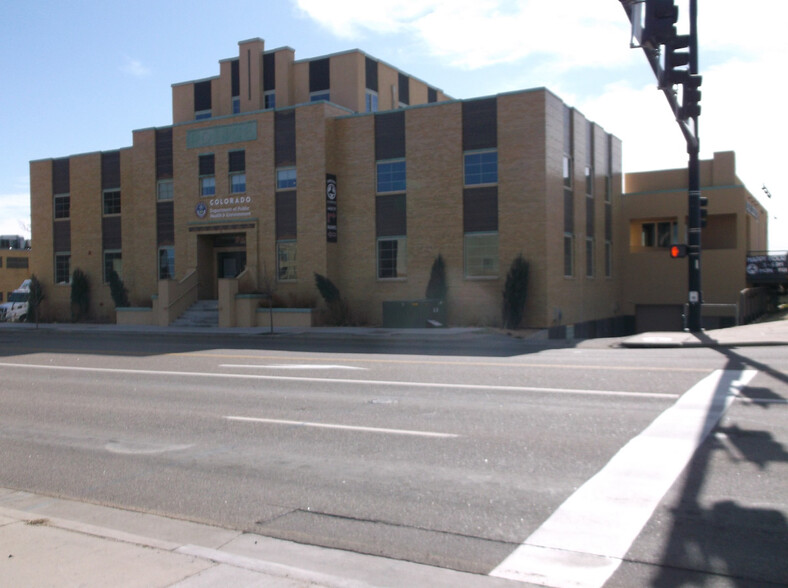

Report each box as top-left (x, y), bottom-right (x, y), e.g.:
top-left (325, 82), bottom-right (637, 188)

top-left (652, 338), bottom-right (788, 588)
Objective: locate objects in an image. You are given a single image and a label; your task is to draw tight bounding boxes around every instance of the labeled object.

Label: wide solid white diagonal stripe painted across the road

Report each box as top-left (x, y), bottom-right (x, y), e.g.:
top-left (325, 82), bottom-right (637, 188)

top-left (490, 370), bottom-right (757, 588)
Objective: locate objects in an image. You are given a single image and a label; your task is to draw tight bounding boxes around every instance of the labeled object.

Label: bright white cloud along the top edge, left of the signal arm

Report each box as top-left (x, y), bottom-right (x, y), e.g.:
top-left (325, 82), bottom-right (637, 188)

top-left (297, 0), bottom-right (631, 69)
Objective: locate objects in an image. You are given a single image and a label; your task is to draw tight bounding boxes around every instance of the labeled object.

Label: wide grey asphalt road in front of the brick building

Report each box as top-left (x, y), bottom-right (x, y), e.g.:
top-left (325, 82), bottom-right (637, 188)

top-left (0, 331), bottom-right (788, 586)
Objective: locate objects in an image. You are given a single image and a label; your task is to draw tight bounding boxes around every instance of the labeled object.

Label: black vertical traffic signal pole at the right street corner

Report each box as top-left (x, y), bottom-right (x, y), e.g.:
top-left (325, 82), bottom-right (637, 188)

top-left (687, 0), bottom-right (703, 333)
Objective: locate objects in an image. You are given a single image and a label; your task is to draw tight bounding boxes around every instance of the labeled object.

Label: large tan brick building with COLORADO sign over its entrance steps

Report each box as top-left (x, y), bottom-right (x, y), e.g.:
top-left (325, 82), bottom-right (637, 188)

top-left (31, 39), bottom-right (631, 336)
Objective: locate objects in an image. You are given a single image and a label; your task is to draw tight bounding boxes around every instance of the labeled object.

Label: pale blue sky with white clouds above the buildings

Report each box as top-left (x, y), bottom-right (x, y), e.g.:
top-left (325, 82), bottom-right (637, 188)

top-left (0, 0), bottom-right (788, 249)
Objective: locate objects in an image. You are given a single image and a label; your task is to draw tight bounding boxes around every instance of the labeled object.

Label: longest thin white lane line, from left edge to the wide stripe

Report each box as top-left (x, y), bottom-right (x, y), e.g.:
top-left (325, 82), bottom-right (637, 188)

top-left (0, 363), bottom-right (679, 399)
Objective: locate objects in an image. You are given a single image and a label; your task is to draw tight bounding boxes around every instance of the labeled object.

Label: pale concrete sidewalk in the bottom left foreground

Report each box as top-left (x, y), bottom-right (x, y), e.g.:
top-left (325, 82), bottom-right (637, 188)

top-left (0, 489), bottom-right (523, 588)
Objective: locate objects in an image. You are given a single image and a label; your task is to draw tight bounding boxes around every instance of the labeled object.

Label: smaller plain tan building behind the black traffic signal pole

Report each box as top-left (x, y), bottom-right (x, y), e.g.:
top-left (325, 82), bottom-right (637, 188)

top-left (619, 152), bottom-right (768, 332)
